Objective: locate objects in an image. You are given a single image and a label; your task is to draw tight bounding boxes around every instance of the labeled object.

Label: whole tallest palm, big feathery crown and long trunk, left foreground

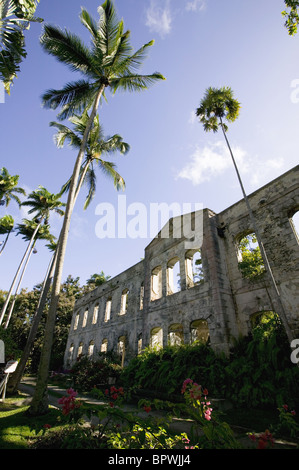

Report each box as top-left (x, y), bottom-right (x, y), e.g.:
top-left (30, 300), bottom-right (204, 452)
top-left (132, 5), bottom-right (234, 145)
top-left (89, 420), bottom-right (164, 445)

top-left (29, 0), bottom-right (164, 415)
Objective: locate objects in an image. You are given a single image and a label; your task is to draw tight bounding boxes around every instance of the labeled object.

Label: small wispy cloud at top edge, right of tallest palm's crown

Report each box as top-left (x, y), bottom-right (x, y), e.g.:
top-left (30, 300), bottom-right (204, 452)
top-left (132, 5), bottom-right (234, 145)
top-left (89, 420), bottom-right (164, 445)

top-left (146, 0), bottom-right (172, 37)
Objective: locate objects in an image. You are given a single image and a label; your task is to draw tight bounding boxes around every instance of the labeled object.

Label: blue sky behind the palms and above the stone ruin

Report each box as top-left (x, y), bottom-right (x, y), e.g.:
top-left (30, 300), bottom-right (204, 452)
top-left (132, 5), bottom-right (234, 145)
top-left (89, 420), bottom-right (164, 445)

top-left (0, 0), bottom-right (299, 290)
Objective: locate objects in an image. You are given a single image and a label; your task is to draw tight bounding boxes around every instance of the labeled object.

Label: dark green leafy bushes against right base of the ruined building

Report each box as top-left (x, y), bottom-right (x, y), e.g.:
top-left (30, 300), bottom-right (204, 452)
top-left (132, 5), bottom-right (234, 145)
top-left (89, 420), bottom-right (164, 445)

top-left (121, 314), bottom-right (299, 408)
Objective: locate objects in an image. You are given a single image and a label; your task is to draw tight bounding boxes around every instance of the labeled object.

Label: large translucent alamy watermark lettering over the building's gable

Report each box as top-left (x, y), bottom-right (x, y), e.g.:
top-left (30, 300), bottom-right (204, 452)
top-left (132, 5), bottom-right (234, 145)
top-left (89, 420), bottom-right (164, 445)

top-left (95, 195), bottom-right (203, 249)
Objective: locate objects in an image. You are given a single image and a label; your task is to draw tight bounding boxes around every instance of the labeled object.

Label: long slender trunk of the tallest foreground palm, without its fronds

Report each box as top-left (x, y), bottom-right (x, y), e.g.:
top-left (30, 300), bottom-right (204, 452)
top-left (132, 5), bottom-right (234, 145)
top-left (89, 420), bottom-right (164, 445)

top-left (28, 84), bottom-right (105, 416)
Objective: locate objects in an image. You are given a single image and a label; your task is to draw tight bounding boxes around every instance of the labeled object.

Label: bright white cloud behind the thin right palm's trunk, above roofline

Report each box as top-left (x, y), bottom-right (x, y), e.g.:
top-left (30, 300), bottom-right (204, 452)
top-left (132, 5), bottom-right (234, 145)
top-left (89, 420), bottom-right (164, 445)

top-left (176, 141), bottom-right (284, 188)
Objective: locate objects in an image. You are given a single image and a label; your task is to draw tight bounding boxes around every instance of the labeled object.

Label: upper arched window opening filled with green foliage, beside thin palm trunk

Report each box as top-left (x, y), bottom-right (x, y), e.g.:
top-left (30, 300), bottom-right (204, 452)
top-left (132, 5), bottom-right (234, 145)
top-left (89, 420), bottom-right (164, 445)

top-left (238, 232), bottom-right (265, 279)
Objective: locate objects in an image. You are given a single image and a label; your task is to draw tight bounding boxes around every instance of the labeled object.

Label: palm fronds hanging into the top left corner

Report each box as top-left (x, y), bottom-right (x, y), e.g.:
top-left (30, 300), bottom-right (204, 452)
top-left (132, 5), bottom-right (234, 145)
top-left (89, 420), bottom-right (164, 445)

top-left (0, 0), bottom-right (42, 94)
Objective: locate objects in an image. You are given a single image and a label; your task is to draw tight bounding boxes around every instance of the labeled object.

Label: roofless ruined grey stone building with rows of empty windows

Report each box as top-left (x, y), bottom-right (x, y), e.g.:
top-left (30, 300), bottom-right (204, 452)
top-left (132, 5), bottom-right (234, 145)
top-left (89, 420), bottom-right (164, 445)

top-left (65, 165), bottom-right (299, 367)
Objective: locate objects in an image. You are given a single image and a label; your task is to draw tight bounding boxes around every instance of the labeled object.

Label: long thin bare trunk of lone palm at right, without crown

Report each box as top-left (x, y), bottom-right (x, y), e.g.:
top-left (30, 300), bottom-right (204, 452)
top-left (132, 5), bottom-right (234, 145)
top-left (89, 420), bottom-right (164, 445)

top-left (220, 117), bottom-right (294, 342)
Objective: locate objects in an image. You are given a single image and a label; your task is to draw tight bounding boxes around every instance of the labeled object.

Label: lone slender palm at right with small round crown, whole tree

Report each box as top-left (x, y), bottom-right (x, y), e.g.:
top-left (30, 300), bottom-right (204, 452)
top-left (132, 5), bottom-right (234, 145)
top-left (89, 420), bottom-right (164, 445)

top-left (196, 87), bottom-right (293, 341)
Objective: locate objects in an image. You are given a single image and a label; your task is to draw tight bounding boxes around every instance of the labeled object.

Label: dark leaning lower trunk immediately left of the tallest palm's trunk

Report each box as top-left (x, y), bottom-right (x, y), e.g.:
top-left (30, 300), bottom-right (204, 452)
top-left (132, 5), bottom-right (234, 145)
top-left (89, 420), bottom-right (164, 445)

top-left (8, 252), bottom-right (57, 393)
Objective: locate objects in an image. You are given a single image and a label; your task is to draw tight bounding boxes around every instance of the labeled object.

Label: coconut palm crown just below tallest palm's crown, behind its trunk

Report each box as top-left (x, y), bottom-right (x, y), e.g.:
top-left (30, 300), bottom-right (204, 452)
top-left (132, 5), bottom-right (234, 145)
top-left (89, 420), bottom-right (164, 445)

top-left (50, 111), bottom-right (130, 209)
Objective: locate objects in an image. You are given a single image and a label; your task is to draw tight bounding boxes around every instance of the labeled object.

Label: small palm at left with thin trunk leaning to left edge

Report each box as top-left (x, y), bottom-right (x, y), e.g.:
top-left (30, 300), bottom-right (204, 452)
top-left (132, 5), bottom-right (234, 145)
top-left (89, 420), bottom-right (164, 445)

top-left (0, 186), bottom-right (65, 325)
